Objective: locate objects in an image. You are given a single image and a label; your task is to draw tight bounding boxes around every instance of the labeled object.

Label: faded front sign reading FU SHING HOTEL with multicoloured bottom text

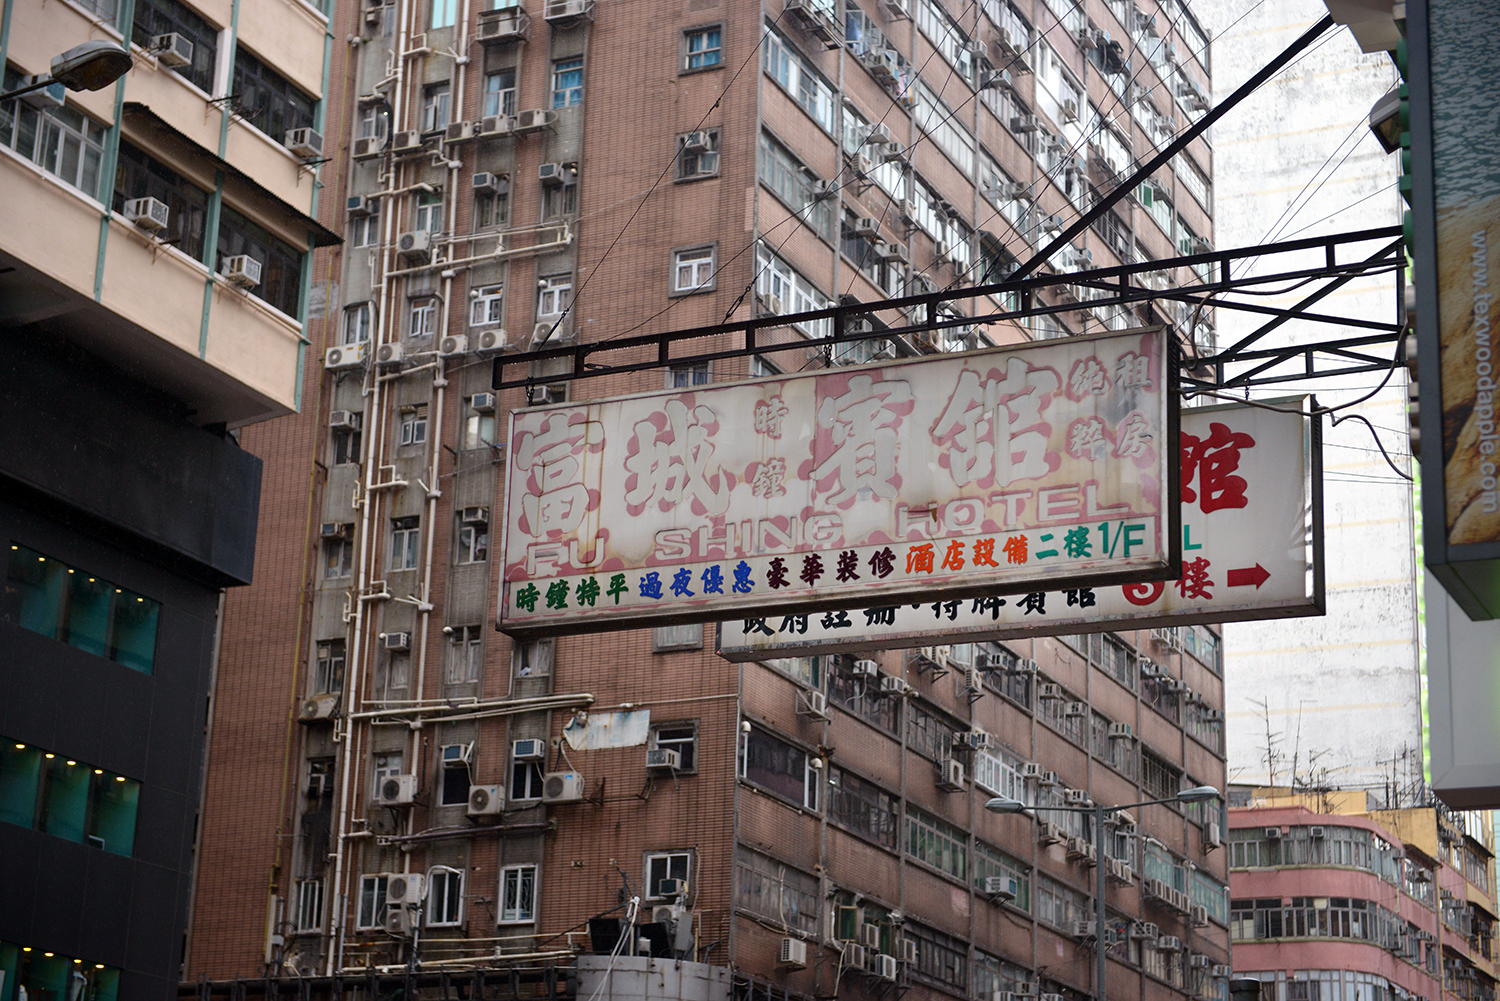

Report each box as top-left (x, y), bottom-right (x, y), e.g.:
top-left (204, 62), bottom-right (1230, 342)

top-left (498, 329), bottom-right (1179, 635)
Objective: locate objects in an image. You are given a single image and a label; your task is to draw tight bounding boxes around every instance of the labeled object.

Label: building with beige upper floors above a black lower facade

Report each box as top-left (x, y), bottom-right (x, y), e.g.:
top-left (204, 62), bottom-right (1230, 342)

top-left (0, 0), bottom-right (335, 1001)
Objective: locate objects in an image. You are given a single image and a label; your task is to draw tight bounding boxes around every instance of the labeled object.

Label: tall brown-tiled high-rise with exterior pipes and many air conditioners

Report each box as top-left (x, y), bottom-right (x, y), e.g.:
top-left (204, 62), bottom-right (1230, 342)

top-left (183, 0), bottom-right (1229, 1001)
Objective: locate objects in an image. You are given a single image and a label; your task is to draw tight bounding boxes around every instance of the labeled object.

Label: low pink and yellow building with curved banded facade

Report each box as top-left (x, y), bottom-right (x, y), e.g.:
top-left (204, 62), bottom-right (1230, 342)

top-left (1226, 786), bottom-right (1500, 1001)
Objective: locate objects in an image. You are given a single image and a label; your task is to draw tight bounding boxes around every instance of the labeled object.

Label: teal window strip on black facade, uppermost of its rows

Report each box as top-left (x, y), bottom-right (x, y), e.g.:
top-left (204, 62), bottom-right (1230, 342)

top-left (0, 542), bottom-right (162, 674)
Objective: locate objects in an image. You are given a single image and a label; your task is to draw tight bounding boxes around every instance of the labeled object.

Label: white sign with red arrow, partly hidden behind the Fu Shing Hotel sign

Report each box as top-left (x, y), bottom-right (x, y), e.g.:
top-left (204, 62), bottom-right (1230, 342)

top-left (719, 398), bottom-right (1323, 660)
